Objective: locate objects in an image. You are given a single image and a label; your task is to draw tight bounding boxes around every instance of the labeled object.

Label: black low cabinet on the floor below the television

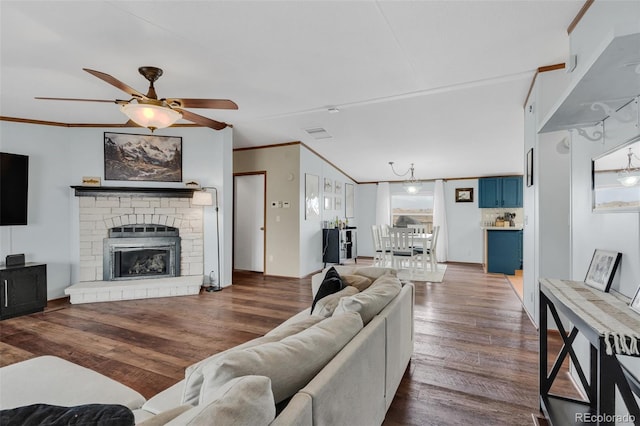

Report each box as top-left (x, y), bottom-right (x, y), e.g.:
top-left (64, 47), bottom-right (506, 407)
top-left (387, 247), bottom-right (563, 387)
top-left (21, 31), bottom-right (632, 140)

top-left (0, 263), bottom-right (47, 319)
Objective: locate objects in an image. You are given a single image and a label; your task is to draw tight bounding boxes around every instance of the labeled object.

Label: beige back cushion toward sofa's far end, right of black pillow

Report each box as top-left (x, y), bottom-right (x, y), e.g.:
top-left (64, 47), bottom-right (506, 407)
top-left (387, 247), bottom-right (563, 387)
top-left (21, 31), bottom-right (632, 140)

top-left (333, 274), bottom-right (402, 325)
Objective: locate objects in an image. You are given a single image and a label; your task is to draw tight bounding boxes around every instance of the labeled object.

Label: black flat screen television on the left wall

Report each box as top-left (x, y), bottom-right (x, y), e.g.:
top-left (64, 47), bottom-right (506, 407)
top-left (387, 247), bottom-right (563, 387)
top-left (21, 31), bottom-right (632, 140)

top-left (0, 152), bottom-right (29, 226)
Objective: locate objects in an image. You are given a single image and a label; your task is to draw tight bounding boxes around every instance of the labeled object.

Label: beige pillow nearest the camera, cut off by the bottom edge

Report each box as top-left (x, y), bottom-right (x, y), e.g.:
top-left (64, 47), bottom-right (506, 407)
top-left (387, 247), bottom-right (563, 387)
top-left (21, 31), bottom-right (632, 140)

top-left (167, 376), bottom-right (276, 426)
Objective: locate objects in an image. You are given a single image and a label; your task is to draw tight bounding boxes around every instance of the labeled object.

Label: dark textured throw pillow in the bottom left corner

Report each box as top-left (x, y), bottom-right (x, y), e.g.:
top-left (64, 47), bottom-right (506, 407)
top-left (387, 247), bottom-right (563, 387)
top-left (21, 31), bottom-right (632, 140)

top-left (0, 404), bottom-right (135, 426)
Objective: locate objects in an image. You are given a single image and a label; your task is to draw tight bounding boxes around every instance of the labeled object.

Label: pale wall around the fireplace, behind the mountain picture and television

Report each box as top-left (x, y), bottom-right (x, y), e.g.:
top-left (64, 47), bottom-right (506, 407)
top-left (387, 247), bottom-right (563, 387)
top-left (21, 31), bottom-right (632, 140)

top-left (0, 121), bottom-right (232, 299)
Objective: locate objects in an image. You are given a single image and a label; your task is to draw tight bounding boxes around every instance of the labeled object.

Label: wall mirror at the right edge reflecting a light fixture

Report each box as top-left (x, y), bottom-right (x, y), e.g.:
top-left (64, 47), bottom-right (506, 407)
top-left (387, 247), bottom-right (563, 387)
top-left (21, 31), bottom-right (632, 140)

top-left (592, 136), bottom-right (640, 212)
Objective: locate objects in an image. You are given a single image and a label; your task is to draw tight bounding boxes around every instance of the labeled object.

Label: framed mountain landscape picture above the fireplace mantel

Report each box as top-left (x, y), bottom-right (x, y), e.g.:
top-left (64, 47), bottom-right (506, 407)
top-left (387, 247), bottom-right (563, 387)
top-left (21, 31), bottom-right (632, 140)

top-left (104, 132), bottom-right (182, 182)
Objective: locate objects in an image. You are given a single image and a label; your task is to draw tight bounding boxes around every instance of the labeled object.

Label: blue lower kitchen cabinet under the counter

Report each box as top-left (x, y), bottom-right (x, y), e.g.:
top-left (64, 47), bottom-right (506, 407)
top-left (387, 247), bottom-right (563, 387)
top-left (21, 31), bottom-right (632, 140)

top-left (487, 230), bottom-right (522, 275)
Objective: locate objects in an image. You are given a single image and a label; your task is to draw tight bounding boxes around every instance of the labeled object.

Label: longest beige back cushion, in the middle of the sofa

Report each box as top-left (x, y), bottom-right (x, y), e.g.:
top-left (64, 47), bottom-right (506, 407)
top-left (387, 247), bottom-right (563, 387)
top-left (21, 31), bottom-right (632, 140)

top-left (200, 313), bottom-right (362, 403)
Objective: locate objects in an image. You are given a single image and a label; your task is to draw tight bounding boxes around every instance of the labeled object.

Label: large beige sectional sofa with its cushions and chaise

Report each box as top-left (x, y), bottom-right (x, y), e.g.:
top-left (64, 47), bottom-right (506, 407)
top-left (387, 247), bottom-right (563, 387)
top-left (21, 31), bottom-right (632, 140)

top-left (0, 266), bottom-right (414, 426)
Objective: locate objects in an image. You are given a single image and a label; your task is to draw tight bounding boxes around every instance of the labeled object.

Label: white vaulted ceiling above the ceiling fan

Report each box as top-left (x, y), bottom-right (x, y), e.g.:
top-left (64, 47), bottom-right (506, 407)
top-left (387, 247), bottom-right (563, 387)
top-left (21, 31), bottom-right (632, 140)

top-left (0, 0), bottom-right (584, 182)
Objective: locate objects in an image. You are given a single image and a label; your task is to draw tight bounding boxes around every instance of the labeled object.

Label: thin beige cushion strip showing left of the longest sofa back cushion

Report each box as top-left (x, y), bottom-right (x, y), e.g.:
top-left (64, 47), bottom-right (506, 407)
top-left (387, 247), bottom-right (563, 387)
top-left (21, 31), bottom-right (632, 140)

top-left (180, 315), bottom-right (324, 405)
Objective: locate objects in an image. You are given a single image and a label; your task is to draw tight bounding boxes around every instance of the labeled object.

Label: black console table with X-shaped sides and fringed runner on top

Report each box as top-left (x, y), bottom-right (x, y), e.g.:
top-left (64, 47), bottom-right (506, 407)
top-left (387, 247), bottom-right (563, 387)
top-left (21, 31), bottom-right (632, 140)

top-left (539, 279), bottom-right (640, 425)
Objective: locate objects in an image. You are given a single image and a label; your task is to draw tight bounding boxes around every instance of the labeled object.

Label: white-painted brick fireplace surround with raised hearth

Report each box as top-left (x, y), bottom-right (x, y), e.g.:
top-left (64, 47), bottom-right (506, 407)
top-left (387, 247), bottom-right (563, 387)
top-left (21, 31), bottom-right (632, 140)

top-left (65, 188), bottom-right (204, 303)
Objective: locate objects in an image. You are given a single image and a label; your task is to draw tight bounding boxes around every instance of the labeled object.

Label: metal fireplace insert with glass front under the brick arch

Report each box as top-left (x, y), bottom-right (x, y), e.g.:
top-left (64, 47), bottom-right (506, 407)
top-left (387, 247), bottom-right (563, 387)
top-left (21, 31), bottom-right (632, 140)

top-left (102, 224), bottom-right (180, 281)
